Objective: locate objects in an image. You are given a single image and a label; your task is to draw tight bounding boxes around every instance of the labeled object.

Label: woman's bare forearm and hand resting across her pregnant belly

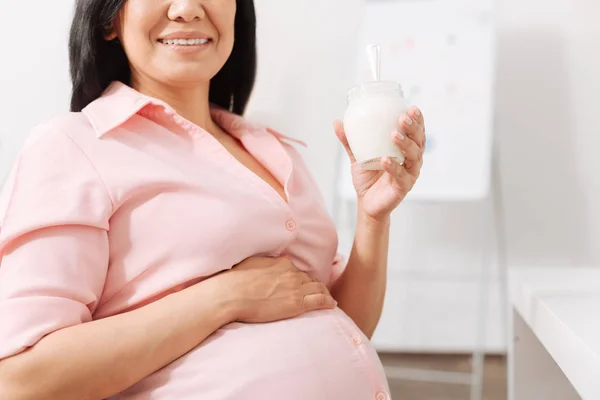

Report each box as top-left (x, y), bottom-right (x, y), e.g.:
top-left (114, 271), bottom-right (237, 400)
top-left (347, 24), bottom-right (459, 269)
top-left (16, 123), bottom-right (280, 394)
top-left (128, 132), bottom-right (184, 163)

top-left (0, 258), bottom-right (335, 400)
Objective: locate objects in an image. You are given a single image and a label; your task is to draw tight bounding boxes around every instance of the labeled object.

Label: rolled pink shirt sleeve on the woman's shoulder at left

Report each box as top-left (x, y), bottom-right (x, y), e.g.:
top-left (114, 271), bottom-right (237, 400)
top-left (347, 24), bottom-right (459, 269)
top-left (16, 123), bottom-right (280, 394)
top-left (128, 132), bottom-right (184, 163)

top-left (0, 126), bottom-right (112, 360)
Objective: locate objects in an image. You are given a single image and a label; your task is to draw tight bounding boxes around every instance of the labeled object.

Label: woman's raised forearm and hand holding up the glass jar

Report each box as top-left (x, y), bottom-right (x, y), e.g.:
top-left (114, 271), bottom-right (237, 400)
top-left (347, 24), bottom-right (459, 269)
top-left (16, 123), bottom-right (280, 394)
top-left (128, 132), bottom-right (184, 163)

top-left (332, 107), bottom-right (426, 337)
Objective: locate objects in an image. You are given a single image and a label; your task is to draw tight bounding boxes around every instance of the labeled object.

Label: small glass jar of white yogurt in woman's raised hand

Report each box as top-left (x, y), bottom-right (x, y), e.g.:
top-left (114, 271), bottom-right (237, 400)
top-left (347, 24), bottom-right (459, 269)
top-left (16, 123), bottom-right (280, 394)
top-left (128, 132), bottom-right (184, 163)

top-left (344, 82), bottom-right (408, 170)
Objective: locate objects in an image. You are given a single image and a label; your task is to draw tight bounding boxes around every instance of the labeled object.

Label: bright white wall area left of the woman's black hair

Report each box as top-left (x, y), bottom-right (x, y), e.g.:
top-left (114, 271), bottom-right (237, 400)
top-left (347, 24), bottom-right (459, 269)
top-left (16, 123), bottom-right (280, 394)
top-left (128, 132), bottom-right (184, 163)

top-left (0, 0), bottom-right (74, 186)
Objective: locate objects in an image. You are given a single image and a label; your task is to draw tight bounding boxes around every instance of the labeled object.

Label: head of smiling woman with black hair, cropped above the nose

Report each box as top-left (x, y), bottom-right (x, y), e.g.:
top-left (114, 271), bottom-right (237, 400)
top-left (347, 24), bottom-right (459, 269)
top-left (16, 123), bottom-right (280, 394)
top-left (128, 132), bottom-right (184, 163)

top-left (69, 0), bottom-right (256, 115)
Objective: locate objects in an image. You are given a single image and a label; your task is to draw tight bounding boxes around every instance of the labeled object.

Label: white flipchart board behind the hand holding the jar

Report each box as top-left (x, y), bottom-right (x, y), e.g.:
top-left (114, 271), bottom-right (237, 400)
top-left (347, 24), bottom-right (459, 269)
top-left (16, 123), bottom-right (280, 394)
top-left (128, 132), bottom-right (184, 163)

top-left (341, 0), bottom-right (494, 201)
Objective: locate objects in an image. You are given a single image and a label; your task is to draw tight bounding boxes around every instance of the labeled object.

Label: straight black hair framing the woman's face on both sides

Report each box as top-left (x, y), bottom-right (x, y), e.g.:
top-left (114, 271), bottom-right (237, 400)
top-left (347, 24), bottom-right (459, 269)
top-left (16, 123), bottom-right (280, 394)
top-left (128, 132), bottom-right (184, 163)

top-left (69, 0), bottom-right (256, 115)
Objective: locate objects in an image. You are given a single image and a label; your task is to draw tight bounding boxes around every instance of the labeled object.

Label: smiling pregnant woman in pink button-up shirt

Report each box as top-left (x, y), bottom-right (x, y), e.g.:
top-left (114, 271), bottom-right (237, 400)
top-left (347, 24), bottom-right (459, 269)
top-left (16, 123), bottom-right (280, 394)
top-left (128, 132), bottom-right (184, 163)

top-left (0, 0), bottom-right (425, 400)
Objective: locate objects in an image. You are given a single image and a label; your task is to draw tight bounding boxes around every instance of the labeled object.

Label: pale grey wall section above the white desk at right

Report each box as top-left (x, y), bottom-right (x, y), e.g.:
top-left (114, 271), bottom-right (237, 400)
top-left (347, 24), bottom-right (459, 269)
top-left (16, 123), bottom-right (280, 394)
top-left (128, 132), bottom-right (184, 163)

top-left (497, 0), bottom-right (600, 265)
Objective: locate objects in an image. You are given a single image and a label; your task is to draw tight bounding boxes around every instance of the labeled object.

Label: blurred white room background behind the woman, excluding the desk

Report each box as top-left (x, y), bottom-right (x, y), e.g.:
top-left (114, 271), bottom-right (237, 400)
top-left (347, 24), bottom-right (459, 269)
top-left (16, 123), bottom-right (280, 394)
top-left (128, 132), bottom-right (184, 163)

top-left (0, 0), bottom-right (600, 400)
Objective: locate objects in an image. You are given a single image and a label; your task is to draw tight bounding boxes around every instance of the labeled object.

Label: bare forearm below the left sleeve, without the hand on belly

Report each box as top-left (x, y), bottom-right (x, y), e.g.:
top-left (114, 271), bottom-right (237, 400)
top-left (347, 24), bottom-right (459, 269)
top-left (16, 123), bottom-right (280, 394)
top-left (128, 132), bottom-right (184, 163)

top-left (0, 279), bottom-right (235, 400)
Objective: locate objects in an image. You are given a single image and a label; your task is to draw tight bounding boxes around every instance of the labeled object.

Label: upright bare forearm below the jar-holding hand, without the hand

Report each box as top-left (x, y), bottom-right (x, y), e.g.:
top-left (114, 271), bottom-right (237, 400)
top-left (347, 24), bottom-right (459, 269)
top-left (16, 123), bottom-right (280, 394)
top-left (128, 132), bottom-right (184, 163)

top-left (331, 212), bottom-right (390, 338)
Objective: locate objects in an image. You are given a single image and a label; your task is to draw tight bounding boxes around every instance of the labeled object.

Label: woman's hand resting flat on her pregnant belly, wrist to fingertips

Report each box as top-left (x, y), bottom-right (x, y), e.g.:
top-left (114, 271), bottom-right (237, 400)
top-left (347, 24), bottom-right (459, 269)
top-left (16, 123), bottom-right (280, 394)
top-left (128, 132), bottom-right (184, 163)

top-left (216, 257), bottom-right (337, 323)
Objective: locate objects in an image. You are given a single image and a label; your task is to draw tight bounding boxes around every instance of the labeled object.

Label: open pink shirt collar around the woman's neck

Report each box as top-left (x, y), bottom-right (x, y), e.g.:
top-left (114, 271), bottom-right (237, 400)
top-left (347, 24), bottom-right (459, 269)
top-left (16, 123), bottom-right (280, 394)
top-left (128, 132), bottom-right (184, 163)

top-left (82, 81), bottom-right (306, 146)
